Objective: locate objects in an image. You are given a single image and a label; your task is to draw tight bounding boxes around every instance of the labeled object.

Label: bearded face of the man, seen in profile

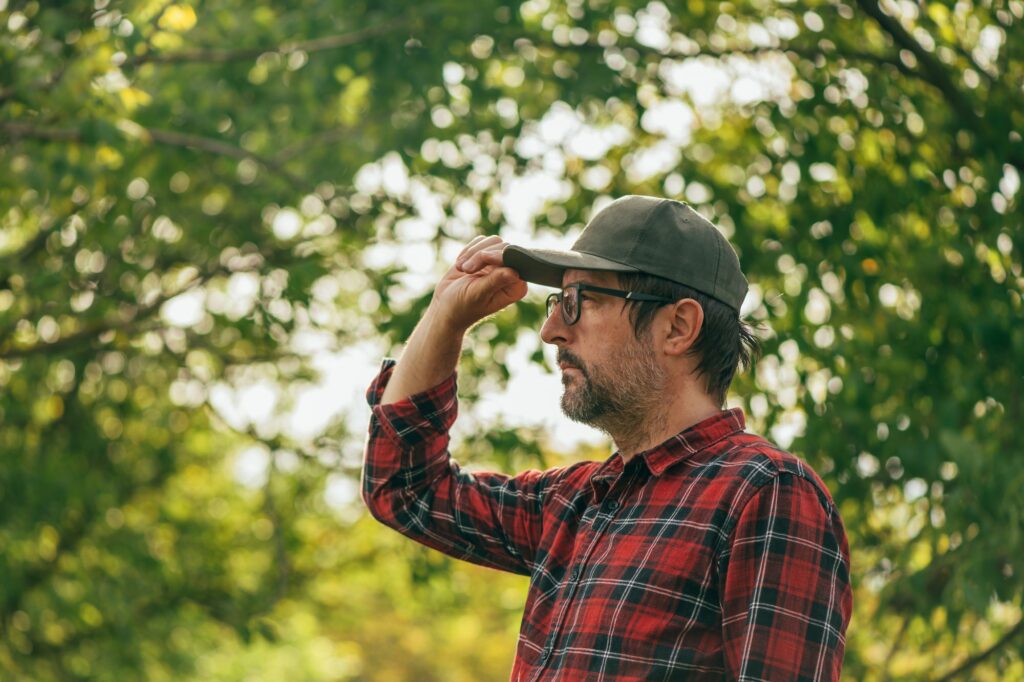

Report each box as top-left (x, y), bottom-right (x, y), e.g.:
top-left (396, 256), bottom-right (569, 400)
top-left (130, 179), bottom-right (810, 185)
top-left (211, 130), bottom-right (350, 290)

top-left (541, 270), bottom-right (667, 430)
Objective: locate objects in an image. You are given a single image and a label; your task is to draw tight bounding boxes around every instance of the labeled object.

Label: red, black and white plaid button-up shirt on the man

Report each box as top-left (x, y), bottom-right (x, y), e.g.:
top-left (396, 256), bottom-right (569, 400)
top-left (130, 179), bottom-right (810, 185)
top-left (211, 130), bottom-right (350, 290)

top-left (362, 359), bottom-right (853, 682)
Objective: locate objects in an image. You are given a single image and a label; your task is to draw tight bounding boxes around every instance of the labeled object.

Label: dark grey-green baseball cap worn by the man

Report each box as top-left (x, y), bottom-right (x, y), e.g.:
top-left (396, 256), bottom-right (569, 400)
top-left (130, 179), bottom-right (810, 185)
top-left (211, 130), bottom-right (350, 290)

top-left (503, 195), bottom-right (746, 312)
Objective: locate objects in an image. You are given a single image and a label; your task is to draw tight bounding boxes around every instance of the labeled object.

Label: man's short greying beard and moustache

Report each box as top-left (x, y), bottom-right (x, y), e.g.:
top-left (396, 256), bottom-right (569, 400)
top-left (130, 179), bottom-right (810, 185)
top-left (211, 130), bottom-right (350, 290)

top-left (558, 335), bottom-right (668, 435)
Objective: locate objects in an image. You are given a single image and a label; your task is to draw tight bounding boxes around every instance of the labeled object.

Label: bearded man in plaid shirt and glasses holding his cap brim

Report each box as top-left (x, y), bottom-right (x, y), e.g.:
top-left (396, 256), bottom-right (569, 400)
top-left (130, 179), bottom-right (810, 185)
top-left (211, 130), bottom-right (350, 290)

top-left (362, 197), bottom-right (852, 682)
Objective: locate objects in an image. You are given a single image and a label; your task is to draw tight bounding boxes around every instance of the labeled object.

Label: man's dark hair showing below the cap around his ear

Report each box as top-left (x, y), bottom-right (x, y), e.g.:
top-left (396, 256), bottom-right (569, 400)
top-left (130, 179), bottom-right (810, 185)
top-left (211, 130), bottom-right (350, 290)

top-left (618, 272), bottom-right (761, 407)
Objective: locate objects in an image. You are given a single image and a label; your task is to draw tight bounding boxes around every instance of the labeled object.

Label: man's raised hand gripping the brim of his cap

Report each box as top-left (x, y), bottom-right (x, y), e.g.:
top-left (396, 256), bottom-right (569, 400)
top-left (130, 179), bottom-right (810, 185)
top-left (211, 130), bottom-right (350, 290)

top-left (430, 236), bottom-right (526, 331)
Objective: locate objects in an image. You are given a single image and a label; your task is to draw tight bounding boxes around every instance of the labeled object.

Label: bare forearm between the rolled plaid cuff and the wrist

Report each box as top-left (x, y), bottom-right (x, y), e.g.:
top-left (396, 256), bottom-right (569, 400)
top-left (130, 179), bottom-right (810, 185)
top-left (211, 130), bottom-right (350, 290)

top-left (381, 305), bottom-right (466, 404)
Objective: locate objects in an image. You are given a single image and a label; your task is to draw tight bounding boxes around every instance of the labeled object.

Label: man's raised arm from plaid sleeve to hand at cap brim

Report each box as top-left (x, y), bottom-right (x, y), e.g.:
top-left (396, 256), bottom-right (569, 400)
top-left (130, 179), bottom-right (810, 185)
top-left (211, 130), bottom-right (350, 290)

top-left (361, 238), bottom-right (567, 573)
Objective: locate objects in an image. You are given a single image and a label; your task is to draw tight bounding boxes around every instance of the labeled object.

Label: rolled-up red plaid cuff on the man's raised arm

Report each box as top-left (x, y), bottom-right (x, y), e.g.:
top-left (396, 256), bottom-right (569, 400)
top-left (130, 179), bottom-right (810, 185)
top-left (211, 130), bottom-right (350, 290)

top-left (367, 357), bottom-right (459, 446)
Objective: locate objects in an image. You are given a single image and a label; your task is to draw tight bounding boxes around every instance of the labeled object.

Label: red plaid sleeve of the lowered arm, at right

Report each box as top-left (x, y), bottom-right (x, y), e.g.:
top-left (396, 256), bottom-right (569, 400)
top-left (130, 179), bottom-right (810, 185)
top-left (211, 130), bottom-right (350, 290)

top-left (720, 473), bottom-right (853, 682)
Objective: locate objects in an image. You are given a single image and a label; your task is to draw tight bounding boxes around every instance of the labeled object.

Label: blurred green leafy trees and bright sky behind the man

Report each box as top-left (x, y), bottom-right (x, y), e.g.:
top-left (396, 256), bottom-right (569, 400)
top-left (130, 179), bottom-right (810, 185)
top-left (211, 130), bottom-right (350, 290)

top-left (0, 0), bottom-right (1024, 681)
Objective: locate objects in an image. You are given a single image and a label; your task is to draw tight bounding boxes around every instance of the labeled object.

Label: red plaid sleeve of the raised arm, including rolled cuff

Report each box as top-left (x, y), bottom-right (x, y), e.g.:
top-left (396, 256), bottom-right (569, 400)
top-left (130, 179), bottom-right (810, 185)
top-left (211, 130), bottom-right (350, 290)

top-left (361, 359), bottom-right (565, 574)
